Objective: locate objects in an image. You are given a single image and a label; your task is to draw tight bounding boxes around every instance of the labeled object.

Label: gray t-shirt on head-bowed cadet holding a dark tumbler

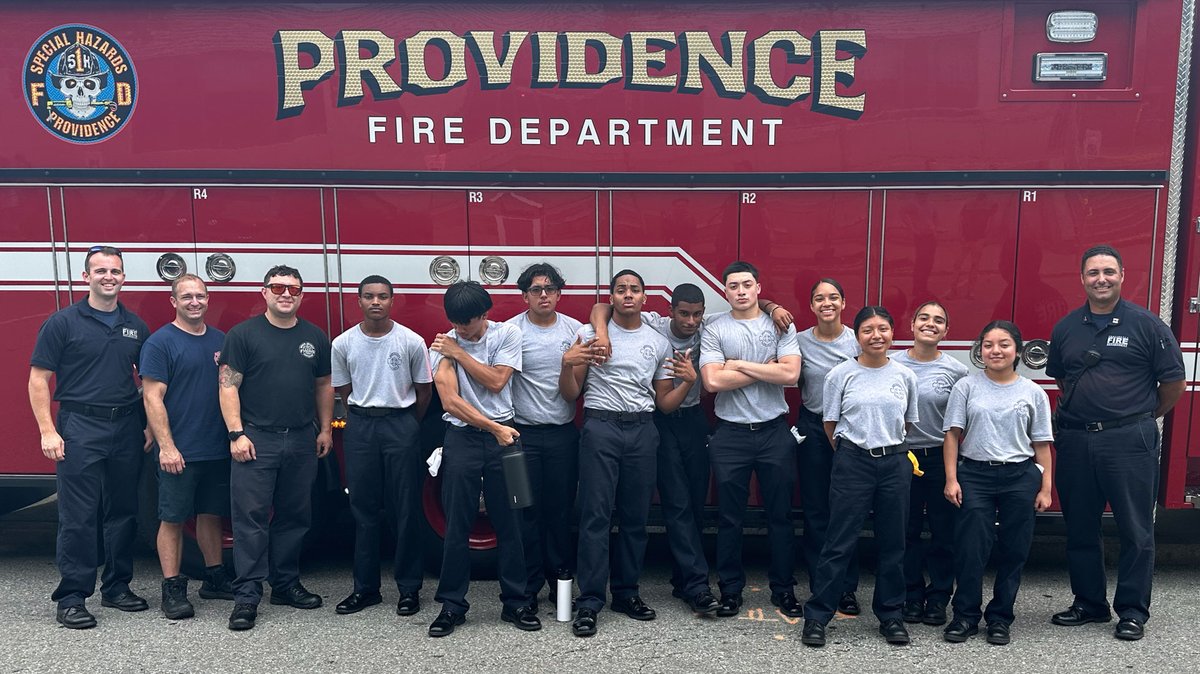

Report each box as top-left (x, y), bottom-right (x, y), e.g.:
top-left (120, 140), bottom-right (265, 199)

top-left (430, 320), bottom-right (521, 427)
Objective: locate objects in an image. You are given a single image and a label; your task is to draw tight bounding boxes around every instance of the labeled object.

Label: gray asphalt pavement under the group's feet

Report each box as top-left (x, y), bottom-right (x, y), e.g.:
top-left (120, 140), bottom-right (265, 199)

top-left (0, 504), bottom-right (1200, 674)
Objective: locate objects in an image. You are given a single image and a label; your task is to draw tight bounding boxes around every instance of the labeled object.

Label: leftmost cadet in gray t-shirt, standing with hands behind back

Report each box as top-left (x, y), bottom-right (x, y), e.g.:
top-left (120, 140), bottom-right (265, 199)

top-left (331, 276), bottom-right (433, 615)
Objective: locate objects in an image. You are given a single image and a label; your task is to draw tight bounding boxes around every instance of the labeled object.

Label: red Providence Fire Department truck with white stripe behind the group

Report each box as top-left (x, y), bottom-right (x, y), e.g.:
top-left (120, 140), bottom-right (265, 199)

top-left (0, 0), bottom-right (1200, 563)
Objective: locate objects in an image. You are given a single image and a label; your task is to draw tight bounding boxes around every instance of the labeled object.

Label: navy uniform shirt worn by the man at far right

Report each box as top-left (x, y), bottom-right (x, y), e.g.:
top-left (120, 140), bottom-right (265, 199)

top-left (1046, 300), bottom-right (1184, 423)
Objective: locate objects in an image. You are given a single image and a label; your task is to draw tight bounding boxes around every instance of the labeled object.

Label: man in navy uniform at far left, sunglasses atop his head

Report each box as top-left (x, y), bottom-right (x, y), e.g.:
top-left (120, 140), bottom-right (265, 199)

top-left (29, 246), bottom-right (150, 630)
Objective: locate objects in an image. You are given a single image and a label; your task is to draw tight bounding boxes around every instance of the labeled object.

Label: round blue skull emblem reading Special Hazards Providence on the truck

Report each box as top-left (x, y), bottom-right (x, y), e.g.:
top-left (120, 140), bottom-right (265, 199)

top-left (24, 24), bottom-right (138, 144)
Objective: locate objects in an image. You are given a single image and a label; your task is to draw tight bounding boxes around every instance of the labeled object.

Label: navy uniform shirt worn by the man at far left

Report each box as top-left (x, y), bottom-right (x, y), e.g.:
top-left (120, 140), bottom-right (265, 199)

top-left (30, 297), bottom-right (150, 408)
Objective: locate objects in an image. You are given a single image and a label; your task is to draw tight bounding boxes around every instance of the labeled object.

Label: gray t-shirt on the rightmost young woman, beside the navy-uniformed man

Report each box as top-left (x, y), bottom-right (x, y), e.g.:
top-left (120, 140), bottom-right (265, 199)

top-left (942, 372), bottom-right (1054, 461)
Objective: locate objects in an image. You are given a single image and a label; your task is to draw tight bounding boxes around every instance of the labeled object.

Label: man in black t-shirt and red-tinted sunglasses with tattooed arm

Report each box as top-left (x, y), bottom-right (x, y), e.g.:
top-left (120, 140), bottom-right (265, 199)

top-left (220, 265), bottom-right (334, 630)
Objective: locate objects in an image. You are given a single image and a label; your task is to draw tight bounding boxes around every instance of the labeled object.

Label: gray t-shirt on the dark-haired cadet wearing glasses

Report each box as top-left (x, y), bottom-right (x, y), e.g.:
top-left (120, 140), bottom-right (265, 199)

top-left (505, 312), bottom-right (580, 426)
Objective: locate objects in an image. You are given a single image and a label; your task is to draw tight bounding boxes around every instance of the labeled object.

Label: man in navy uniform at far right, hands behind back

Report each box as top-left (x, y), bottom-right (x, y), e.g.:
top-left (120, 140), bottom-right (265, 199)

top-left (1046, 246), bottom-right (1184, 640)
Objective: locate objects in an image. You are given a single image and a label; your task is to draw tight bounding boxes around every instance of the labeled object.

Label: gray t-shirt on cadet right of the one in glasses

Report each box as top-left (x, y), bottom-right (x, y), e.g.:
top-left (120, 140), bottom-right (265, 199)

top-left (578, 320), bottom-right (671, 411)
